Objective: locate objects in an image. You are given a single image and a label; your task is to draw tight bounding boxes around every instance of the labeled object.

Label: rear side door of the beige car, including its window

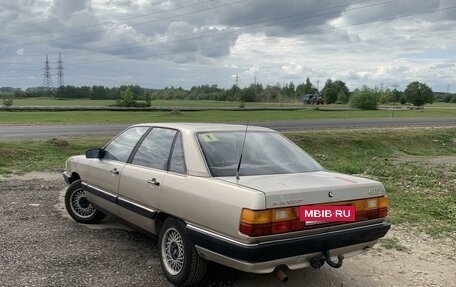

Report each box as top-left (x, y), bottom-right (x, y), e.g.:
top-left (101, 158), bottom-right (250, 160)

top-left (117, 127), bottom-right (178, 232)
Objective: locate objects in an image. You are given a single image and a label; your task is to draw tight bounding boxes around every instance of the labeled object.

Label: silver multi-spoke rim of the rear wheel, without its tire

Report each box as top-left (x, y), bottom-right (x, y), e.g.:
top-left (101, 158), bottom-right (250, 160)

top-left (161, 228), bottom-right (184, 275)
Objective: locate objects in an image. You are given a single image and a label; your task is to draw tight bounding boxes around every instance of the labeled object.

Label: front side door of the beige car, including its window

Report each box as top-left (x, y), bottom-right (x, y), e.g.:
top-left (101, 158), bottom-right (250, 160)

top-left (83, 126), bottom-right (150, 214)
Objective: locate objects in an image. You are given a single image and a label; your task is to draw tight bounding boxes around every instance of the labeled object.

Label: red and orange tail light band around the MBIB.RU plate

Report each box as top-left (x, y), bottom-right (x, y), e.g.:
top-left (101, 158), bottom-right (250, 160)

top-left (239, 196), bottom-right (388, 236)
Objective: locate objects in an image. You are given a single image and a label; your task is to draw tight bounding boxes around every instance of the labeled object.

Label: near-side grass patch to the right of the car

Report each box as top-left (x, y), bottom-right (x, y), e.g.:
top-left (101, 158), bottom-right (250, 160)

top-left (286, 128), bottom-right (456, 237)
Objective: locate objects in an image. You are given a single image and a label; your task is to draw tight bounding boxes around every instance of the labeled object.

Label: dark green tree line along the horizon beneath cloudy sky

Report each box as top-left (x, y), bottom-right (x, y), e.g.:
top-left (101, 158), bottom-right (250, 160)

top-left (0, 78), bottom-right (448, 109)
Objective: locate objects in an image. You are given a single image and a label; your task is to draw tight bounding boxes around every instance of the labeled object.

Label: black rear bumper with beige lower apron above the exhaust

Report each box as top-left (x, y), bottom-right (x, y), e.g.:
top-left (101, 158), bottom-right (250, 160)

top-left (187, 222), bottom-right (390, 273)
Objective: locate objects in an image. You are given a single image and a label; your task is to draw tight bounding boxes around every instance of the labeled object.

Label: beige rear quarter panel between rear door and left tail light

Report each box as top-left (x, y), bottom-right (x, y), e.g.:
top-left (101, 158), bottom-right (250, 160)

top-left (160, 173), bottom-right (265, 240)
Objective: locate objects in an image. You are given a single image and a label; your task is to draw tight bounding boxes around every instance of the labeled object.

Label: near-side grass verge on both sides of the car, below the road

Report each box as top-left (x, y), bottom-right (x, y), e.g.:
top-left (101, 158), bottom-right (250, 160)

top-left (0, 128), bottom-right (456, 237)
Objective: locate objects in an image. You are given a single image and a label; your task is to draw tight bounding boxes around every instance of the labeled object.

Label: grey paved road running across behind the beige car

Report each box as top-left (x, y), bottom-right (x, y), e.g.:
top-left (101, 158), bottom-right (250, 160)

top-left (0, 117), bottom-right (456, 140)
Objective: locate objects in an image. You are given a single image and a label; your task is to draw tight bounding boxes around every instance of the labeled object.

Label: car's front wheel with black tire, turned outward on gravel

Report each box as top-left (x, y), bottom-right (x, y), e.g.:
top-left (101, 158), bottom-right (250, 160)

top-left (65, 180), bottom-right (105, 223)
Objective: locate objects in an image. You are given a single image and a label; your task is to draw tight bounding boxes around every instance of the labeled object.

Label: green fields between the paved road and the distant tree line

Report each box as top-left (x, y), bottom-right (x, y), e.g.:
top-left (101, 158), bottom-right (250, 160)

top-left (0, 98), bottom-right (456, 125)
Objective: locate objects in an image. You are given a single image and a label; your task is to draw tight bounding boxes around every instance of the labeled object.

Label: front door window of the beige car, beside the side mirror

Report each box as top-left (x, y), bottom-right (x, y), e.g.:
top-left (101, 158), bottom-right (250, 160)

top-left (103, 127), bottom-right (149, 162)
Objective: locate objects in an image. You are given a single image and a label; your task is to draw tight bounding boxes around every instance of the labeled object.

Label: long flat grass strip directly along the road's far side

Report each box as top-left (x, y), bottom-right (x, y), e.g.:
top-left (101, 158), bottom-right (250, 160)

top-left (0, 108), bottom-right (456, 125)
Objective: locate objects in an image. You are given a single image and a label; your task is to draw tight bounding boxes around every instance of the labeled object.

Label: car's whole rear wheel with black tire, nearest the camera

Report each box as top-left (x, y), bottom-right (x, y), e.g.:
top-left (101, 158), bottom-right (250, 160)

top-left (159, 217), bottom-right (207, 286)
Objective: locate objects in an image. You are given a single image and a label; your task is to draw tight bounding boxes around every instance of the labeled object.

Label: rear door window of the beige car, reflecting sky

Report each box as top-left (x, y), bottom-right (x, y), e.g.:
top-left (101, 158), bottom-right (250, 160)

top-left (131, 128), bottom-right (177, 170)
